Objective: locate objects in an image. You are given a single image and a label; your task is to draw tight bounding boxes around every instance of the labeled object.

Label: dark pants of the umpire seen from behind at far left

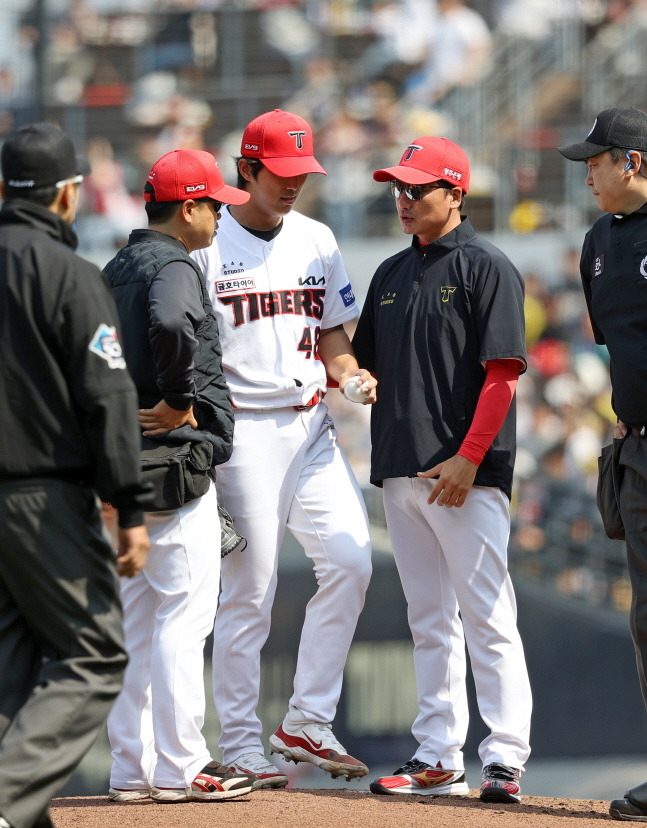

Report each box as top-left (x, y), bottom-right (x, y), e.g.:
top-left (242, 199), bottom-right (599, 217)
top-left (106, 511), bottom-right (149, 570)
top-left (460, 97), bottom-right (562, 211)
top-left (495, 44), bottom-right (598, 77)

top-left (0, 478), bottom-right (127, 828)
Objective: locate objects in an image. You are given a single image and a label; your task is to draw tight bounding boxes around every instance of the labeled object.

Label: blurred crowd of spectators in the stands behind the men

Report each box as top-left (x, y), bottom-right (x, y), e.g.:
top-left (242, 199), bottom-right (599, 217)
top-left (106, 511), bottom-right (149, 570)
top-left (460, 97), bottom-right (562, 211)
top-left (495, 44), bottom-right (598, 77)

top-left (0, 0), bottom-right (647, 612)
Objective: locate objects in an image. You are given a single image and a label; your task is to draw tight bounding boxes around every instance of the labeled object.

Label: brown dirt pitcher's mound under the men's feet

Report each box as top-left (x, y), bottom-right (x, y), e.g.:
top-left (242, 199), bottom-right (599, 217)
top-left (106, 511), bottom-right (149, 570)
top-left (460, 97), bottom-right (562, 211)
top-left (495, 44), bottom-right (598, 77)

top-left (52, 788), bottom-right (611, 828)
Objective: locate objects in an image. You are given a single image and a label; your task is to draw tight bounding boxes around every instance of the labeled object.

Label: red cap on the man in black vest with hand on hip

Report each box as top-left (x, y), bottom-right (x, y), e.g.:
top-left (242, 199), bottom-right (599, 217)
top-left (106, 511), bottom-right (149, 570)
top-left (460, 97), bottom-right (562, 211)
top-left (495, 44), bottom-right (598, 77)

top-left (144, 150), bottom-right (249, 204)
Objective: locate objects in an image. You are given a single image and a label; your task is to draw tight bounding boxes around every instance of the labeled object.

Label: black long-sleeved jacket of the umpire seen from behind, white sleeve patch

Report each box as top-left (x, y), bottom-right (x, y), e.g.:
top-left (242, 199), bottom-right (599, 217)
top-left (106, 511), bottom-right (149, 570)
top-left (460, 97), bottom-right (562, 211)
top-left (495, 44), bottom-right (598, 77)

top-left (0, 199), bottom-right (144, 527)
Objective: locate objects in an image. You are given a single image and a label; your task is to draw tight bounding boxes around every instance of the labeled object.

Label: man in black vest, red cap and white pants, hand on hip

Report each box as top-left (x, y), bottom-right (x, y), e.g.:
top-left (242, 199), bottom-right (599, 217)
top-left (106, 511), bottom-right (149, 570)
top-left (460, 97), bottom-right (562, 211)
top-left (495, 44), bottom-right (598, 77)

top-left (104, 150), bottom-right (256, 802)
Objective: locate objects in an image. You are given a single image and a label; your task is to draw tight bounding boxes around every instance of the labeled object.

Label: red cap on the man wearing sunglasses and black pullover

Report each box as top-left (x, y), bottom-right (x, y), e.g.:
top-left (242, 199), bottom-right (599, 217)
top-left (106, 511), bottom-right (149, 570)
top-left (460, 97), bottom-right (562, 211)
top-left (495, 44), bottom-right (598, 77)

top-left (373, 135), bottom-right (470, 193)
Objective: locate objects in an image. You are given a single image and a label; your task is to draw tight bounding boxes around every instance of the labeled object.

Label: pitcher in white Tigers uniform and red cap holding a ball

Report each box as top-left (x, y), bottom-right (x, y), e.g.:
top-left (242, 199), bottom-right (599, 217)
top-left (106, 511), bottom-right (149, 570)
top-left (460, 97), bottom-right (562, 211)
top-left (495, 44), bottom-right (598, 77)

top-left (194, 109), bottom-right (377, 788)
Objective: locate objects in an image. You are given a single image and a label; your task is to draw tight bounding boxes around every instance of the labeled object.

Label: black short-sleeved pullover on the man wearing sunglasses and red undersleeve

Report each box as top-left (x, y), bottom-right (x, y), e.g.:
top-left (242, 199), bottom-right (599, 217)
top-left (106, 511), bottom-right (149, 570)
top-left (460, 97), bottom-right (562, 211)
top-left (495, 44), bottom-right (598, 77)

top-left (353, 218), bottom-right (525, 497)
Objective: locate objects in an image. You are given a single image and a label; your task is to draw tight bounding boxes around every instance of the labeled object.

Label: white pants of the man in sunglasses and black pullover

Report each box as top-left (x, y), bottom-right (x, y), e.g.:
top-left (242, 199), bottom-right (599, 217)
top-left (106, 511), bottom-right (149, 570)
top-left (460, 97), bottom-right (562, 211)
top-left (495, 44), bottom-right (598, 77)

top-left (384, 477), bottom-right (532, 770)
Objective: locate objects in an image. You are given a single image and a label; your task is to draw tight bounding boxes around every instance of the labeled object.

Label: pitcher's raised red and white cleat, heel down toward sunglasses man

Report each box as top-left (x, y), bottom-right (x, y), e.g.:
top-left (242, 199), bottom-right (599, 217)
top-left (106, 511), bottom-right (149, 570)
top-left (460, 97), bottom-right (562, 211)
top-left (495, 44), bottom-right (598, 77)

top-left (269, 722), bottom-right (368, 782)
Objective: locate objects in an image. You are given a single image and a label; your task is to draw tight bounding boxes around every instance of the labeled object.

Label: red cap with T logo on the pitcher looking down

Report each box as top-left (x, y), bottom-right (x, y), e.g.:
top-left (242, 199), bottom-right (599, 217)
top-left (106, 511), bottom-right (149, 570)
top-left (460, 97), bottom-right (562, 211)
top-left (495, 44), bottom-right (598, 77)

top-left (240, 109), bottom-right (326, 178)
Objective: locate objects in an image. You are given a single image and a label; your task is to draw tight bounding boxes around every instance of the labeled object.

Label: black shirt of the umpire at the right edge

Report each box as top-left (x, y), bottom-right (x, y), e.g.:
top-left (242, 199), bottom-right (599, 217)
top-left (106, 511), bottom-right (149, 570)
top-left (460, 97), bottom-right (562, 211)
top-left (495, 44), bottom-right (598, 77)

top-left (580, 204), bottom-right (647, 426)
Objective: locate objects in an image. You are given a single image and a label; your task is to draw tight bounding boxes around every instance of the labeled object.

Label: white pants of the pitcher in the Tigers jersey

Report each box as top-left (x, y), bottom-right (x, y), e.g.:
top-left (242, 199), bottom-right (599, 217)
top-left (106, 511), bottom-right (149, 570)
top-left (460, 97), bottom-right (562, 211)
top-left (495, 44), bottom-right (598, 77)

top-left (213, 403), bottom-right (371, 762)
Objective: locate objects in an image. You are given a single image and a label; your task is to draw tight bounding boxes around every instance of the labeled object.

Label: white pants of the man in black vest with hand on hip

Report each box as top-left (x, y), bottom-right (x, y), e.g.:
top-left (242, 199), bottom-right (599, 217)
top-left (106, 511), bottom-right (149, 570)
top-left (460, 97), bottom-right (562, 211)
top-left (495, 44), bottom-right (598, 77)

top-left (108, 484), bottom-right (220, 788)
